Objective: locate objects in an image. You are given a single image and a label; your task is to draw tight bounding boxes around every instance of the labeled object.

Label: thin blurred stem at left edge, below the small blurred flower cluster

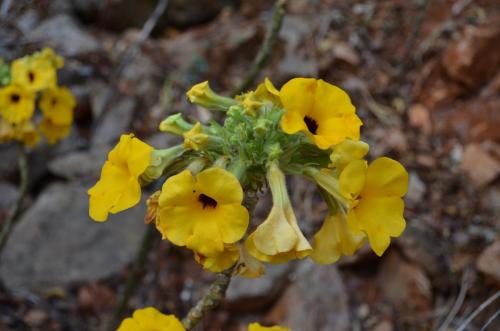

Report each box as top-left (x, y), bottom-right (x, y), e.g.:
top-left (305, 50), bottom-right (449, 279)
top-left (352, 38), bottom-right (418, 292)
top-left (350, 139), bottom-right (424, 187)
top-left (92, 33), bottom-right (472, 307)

top-left (0, 145), bottom-right (29, 251)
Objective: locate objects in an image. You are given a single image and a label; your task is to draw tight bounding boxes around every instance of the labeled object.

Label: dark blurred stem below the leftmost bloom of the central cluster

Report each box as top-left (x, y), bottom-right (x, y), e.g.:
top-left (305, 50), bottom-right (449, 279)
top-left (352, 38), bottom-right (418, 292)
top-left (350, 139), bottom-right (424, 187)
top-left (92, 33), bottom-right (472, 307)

top-left (106, 225), bottom-right (157, 331)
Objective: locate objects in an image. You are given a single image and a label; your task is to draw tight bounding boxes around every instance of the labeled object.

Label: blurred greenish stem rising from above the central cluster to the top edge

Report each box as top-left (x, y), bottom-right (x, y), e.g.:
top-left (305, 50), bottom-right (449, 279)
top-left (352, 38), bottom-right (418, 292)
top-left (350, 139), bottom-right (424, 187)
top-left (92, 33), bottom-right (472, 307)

top-left (231, 0), bottom-right (286, 95)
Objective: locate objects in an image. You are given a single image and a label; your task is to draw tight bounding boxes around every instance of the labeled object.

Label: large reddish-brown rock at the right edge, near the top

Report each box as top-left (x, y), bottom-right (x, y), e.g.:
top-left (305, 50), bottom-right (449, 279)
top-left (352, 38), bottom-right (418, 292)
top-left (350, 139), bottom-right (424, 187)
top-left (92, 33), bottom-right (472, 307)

top-left (443, 17), bottom-right (500, 88)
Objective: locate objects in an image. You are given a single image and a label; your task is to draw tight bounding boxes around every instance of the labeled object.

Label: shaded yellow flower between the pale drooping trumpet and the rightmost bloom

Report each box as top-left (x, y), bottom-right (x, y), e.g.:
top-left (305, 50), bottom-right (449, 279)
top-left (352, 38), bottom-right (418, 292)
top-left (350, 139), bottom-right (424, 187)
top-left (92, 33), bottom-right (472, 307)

top-left (310, 211), bottom-right (365, 264)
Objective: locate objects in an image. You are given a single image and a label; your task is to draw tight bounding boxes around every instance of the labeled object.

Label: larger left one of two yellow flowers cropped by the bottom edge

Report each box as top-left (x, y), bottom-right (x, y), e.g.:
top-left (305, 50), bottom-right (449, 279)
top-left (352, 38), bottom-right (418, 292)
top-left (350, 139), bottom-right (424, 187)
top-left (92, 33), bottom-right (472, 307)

top-left (117, 307), bottom-right (186, 331)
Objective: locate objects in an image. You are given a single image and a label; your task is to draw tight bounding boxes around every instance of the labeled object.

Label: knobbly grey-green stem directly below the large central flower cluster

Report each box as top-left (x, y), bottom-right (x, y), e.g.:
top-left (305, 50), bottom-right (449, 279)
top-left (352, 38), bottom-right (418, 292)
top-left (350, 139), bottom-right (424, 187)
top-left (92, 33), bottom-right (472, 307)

top-left (182, 267), bottom-right (234, 331)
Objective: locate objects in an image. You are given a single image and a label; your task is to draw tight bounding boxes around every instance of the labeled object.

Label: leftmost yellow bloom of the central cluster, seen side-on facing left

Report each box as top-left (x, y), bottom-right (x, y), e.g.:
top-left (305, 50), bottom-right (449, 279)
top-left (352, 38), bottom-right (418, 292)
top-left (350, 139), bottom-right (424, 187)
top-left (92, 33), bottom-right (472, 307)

top-left (88, 134), bottom-right (153, 222)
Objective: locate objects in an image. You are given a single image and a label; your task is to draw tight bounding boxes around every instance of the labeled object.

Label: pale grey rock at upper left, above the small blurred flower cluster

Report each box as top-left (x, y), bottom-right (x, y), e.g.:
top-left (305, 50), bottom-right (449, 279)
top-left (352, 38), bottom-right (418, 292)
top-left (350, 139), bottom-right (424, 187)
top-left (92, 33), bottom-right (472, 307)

top-left (29, 14), bottom-right (101, 56)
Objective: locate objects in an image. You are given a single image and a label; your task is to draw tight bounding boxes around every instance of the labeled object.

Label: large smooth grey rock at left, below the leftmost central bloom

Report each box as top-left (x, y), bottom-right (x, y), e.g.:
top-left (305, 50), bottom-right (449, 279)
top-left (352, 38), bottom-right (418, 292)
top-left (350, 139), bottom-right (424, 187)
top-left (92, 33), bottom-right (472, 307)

top-left (0, 183), bottom-right (145, 293)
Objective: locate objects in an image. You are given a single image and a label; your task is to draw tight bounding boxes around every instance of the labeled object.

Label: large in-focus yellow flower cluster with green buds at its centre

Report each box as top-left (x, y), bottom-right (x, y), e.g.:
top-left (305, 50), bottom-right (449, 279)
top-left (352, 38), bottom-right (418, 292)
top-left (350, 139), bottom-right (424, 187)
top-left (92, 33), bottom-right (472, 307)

top-left (89, 78), bottom-right (408, 277)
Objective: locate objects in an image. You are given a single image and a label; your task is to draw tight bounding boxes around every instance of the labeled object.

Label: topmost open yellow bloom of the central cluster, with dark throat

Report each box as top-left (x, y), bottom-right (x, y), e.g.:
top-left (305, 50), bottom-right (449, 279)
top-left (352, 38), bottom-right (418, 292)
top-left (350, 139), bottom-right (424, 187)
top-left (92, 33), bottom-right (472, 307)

top-left (280, 78), bottom-right (362, 149)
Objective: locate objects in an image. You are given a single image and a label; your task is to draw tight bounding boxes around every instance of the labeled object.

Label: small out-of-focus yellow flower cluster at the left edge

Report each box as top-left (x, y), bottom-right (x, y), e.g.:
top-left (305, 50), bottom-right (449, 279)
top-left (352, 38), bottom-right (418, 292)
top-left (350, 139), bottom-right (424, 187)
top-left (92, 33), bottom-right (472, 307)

top-left (0, 48), bottom-right (76, 147)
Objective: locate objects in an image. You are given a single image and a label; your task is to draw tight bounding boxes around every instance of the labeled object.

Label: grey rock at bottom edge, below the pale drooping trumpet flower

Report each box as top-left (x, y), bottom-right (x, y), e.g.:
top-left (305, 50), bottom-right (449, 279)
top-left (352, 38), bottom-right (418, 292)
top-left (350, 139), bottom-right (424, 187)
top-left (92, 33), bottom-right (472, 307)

top-left (268, 260), bottom-right (351, 331)
